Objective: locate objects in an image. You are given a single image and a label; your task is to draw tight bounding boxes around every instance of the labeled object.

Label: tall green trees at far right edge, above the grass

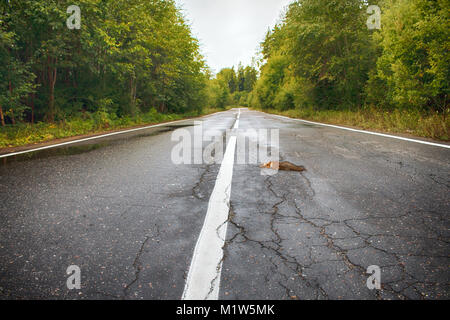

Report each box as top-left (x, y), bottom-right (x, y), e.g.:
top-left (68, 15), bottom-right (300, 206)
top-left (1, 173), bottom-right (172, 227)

top-left (367, 0), bottom-right (450, 112)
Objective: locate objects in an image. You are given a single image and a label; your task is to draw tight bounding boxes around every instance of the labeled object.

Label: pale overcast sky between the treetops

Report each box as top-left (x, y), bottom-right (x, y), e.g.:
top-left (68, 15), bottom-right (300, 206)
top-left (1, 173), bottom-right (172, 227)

top-left (176, 0), bottom-right (292, 72)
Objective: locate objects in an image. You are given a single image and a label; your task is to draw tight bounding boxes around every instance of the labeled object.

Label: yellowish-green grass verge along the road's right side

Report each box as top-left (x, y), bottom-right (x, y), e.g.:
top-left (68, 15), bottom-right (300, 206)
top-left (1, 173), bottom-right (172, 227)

top-left (253, 108), bottom-right (450, 141)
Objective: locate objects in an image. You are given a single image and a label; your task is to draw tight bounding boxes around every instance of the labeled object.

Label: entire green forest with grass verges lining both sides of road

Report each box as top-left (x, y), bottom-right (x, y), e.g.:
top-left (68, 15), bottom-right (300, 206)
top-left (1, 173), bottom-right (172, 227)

top-left (0, 0), bottom-right (450, 148)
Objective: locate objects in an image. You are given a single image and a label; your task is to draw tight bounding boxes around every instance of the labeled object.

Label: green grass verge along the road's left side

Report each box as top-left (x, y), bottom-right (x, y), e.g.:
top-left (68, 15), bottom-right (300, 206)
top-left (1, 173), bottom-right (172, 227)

top-left (0, 108), bottom-right (224, 148)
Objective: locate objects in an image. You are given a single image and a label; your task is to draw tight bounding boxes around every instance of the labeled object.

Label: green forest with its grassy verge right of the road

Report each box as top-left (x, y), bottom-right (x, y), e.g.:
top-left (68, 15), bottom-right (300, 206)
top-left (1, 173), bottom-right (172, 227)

top-left (247, 0), bottom-right (450, 140)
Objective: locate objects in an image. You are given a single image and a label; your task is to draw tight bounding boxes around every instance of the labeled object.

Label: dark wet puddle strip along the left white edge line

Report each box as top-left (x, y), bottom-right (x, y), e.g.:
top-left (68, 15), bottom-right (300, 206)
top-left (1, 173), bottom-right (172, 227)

top-left (0, 124), bottom-right (193, 167)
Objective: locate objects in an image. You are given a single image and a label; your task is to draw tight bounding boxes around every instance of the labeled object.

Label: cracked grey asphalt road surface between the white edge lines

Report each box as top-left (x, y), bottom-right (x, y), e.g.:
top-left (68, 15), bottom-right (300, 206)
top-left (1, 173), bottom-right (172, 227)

top-left (0, 109), bottom-right (450, 300)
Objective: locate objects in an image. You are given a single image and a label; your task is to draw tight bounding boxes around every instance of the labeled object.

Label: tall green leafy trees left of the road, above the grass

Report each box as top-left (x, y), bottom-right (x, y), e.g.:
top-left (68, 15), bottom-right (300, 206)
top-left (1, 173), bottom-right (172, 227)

top-left (0, 0), bottom-right (207, 126)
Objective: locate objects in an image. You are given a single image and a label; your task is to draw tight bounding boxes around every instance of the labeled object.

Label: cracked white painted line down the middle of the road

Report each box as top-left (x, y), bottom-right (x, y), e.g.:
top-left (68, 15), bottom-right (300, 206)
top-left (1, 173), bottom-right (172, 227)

top-left (182, 110), bottom-right (240, 300)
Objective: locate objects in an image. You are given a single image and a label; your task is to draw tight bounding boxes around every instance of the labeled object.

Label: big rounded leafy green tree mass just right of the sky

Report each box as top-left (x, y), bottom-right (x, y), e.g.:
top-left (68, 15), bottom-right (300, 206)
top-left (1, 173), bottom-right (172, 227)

top-left (251, 0), bottom-right (375, 110)
